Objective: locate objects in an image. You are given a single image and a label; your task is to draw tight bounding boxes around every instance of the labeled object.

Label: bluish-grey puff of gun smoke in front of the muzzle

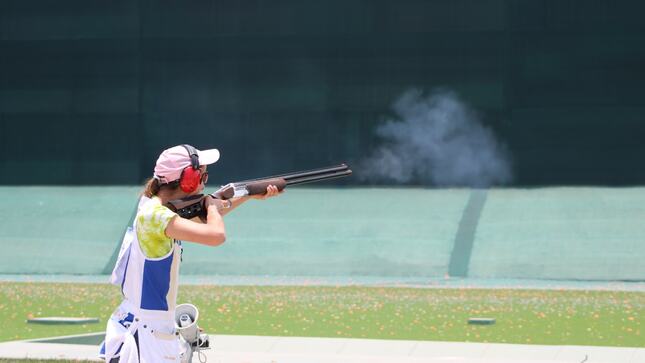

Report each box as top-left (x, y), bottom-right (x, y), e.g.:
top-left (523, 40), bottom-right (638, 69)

top-left (358, 89), bottom-right (512, 188)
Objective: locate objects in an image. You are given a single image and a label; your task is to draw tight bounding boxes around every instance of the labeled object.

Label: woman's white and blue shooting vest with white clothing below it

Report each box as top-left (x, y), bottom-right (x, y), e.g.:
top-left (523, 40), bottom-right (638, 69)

top-left (100, 197), bottom-right (182, 362)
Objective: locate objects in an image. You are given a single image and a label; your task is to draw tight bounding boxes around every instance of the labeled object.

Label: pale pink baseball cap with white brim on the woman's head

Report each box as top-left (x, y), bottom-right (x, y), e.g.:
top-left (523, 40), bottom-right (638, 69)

top-left (154, 145), bottom-right (219, 184)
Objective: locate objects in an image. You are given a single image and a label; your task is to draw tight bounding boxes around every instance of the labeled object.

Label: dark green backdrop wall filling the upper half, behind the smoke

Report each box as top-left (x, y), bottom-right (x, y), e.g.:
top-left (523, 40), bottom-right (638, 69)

top-left (0, 0), bottom-right (645, 185)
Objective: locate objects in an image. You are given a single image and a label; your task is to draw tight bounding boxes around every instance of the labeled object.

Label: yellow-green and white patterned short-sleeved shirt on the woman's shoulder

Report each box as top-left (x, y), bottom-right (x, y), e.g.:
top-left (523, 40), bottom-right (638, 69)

top-left (136, 197), bottom-right (177, 258)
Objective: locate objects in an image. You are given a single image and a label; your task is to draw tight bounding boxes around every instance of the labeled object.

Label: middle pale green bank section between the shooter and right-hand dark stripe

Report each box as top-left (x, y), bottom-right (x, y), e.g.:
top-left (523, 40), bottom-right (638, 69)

top-left (199, 188), bottom-right (469, 276)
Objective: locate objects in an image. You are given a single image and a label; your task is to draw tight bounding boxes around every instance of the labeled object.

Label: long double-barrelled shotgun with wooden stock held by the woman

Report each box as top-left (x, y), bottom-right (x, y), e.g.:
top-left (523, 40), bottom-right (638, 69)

top-left (166, 163), bottom-right (352, 221)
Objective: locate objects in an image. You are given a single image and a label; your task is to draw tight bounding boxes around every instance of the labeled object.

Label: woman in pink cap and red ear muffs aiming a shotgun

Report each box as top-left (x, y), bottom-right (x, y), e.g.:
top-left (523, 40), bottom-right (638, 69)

top-left (101, 145), bottom-right (279, 363)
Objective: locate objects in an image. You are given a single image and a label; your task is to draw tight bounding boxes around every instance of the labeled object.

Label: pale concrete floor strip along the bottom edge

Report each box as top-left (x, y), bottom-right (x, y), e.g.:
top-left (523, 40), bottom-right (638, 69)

top-left (0, 333), bottom-right (645, 363)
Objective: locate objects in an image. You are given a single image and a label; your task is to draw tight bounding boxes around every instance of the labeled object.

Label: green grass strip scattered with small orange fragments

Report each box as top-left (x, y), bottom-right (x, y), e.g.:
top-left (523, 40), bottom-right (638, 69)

top-left (0, 283), bottom-right (645, 347)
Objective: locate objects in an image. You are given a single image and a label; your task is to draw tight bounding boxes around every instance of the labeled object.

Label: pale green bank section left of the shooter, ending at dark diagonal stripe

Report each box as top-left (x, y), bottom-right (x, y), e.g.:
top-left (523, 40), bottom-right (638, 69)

top-left (0, 187), bottom-right (139, 274)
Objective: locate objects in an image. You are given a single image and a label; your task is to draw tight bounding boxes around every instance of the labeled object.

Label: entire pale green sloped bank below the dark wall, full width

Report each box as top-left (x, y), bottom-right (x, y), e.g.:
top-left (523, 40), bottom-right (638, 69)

top-left (0, 187), bottom-right (645, 283)
